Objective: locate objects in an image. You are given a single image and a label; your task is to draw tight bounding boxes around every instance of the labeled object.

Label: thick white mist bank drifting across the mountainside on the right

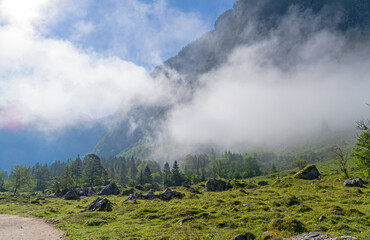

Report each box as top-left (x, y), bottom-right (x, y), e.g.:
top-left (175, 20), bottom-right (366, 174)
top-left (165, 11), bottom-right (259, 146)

top-left (150, 7), bottom-right (370, 158)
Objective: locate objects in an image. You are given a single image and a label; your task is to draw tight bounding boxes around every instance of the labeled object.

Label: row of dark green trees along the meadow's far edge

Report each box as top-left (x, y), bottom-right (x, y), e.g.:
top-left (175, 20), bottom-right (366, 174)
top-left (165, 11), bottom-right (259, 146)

top-left (0, 151), bottom-right (262, 194)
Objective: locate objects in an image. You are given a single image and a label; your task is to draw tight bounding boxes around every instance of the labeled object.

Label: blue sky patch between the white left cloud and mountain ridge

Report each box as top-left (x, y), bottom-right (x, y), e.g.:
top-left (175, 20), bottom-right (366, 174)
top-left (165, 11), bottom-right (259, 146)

top-left (47, 0), bottom-right (235, 70)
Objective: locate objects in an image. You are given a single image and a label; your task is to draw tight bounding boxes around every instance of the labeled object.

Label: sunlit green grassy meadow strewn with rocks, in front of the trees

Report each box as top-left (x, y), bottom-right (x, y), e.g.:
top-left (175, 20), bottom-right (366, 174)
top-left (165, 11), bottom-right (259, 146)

top-left (0, 164), bottom-right (370, 239)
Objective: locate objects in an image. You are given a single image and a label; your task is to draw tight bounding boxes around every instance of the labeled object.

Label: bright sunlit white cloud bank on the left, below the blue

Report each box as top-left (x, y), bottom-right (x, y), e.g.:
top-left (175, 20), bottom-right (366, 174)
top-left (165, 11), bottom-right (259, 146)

top-left (0, 0), bottom-right (191, 130)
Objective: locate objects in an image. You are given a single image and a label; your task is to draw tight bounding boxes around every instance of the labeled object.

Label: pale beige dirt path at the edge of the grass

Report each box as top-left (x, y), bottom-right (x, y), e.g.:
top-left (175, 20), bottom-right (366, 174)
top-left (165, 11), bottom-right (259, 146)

top-left (0, 214), bottom-right (64, 240)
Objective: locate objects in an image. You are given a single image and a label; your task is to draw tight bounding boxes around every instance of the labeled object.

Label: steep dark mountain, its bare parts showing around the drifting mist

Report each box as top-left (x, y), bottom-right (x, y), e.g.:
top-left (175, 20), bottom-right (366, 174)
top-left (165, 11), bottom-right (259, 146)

top-left (94, 0), bottom-right (370, 160)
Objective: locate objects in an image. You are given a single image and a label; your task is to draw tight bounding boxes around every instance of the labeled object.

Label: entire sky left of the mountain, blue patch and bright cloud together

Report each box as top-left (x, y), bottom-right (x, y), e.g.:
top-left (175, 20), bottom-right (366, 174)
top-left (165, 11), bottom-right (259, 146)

top-left (0, 0), bottom-right (234, 130)
